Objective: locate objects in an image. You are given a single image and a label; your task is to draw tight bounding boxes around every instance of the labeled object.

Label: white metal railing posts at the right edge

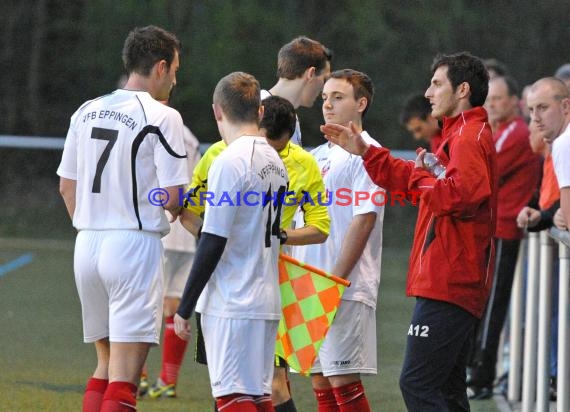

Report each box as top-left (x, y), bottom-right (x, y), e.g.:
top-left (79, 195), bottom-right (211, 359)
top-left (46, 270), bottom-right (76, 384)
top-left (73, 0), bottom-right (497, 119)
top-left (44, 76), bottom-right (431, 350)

top-left (508, 228), bottom-right (570, 412)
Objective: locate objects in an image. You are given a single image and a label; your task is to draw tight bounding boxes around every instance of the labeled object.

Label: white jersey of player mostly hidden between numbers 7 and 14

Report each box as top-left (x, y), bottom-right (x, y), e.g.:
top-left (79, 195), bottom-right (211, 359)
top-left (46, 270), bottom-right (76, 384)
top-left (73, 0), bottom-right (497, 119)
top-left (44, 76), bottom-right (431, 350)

top-left (162, 126), bottom-right (201, 253)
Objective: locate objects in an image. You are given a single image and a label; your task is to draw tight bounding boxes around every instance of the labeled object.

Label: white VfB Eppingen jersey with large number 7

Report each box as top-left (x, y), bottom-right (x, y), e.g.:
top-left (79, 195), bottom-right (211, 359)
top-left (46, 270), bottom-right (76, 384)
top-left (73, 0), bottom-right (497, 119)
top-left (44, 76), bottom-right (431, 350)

top-left (57, 89), bottom-right (188, 235)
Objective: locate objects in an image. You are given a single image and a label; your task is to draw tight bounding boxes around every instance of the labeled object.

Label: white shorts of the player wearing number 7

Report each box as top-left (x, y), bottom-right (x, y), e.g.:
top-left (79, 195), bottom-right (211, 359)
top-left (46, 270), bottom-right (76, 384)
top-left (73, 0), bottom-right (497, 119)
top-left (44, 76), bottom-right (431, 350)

top-left (74, 230), bottom-right (163, 344)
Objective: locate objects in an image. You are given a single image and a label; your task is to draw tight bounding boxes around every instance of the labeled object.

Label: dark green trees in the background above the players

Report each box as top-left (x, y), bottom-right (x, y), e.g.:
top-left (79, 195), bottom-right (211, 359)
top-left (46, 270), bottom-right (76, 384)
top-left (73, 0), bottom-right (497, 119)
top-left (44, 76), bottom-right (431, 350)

top-left (0, 0), bottom-right (570, 148)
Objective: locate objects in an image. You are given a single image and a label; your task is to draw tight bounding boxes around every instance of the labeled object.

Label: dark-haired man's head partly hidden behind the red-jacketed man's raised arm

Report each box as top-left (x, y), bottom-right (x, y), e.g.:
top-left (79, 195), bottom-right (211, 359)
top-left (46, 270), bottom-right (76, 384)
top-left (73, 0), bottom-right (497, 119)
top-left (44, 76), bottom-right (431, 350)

top-left (400, 93), bottom-right (441, 153)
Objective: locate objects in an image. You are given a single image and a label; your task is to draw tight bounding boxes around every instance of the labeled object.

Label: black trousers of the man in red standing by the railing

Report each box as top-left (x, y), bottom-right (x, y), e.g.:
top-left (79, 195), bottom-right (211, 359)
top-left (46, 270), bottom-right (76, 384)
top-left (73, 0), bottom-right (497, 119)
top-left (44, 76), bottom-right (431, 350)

top-left (469, 239), bottom-right (520, 387)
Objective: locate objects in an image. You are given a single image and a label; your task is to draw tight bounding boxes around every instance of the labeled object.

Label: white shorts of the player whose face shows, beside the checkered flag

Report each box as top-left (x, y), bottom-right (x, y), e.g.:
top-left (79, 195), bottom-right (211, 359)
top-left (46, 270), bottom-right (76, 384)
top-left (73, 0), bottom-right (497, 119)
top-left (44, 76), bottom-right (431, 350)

top-left (311, 300), bottom-right (377, 376)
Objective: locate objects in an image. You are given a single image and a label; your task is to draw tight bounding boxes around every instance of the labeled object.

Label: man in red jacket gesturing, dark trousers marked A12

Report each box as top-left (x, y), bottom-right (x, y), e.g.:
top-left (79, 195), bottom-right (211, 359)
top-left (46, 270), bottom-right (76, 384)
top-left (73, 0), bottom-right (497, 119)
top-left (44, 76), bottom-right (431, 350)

top-left (321, 53), bottom-right (498, 412)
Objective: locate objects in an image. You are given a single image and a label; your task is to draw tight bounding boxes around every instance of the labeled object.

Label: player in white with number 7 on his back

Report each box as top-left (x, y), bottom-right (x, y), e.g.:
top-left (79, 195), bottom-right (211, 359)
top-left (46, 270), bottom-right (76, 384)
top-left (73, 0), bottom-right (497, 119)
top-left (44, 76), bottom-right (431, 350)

top-left (57, 26), bottom-right (188, 411)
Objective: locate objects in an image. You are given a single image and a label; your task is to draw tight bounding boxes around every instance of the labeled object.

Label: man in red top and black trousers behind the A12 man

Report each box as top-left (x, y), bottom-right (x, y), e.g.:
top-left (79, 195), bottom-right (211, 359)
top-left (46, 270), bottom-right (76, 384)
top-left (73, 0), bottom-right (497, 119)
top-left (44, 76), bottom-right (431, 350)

top-left (467, 76), bottom-right (540, 399)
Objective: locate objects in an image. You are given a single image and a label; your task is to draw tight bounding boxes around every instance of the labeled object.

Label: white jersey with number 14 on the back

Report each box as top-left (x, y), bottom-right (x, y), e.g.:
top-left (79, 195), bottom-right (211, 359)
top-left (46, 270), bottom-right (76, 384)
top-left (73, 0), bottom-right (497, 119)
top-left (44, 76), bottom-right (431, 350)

top-left (196, 136), bottom-right (288, 320)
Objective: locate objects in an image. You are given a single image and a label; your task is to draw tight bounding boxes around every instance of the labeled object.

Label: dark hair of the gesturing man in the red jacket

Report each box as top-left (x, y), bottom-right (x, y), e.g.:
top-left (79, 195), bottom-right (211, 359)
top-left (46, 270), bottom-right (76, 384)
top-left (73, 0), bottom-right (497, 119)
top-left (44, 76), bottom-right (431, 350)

top-left (431, 52), bottom-right (489, 107)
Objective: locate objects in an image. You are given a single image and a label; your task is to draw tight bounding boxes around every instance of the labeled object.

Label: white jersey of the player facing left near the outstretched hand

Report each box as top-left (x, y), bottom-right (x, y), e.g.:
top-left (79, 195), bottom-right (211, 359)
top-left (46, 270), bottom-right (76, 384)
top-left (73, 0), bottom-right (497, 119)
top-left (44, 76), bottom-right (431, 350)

top-left (291, 132), bottom-right (385, 308)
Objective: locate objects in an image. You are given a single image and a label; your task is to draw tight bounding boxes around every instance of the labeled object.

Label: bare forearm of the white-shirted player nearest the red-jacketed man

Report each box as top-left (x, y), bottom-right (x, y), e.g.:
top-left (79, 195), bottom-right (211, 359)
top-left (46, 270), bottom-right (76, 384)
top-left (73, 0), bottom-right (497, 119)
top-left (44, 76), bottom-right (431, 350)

top-left (332, 212), bottom-right (376, 279)
